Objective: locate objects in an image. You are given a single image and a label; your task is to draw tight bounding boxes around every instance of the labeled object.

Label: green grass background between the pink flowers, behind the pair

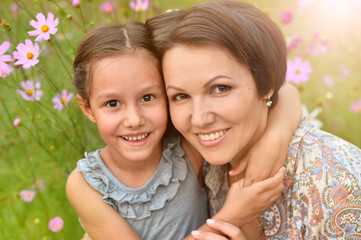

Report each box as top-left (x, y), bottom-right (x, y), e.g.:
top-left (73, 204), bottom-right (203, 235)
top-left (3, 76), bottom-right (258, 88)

top-left (0, 0), bottom-right (361, 240)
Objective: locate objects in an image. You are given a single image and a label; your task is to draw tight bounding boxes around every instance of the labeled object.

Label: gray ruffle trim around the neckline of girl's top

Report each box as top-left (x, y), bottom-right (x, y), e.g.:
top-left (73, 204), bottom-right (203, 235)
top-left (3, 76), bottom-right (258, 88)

top-left (77, 138), bottom-right (188, 219)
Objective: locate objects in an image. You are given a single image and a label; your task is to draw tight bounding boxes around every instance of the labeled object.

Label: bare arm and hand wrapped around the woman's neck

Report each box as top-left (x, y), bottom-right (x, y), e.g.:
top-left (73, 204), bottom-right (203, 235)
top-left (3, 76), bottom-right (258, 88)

top-left (229, 83), bottom-right (302, 186)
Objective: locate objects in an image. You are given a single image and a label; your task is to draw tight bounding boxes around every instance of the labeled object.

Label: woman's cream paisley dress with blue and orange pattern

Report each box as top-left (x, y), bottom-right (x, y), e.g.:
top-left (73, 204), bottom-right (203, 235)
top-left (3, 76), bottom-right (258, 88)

top-left (205, 121), bottom-right (361, 239)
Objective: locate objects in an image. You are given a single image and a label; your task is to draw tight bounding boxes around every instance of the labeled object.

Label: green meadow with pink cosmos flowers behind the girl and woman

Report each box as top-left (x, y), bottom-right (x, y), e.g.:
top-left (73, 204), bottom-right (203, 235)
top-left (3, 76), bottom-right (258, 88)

top-left (0, 0), bottom-right (361, 240)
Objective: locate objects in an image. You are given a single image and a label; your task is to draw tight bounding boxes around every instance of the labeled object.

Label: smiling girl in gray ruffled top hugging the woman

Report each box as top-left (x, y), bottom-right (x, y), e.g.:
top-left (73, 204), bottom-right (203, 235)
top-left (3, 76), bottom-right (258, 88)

top-left (66, 22), bottom-right (300, 240)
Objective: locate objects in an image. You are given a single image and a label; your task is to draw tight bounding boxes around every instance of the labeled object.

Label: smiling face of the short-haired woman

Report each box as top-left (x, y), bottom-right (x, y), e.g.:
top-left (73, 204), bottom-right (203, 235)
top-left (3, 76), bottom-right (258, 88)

top-left (163, 45), bottom-right (268, 165)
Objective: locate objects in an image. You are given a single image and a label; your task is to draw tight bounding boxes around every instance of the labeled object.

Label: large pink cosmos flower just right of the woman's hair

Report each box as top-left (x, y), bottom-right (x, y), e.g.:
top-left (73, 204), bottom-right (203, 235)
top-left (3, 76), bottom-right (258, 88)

top-left (286, 57), bottom-right (312, 84)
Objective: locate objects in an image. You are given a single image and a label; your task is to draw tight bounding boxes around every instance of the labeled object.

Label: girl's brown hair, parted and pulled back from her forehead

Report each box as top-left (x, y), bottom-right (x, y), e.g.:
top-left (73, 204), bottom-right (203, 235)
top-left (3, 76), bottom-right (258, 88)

top-left (73, 21), bottom-right (159, 105)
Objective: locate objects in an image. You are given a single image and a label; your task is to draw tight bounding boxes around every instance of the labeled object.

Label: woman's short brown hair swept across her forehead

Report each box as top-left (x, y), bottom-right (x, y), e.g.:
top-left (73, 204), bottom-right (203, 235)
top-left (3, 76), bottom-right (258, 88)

top-left (146, 0), bottom-right (287, 103)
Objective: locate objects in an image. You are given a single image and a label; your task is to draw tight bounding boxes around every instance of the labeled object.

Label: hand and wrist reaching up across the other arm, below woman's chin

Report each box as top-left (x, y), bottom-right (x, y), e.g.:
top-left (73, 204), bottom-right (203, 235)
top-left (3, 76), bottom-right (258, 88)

top-left (185, 167), bottom-right (285, 240)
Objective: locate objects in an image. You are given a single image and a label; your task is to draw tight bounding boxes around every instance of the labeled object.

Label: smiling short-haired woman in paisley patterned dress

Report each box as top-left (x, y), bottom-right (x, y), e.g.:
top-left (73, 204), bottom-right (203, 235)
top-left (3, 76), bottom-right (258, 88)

top-left (147, 0), bottom-right (361, 239)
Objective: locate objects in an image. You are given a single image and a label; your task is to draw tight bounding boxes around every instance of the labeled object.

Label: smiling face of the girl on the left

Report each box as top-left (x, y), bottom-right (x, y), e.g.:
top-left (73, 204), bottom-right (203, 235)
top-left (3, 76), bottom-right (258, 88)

top-left (81, 50), bottom-right (167, 161)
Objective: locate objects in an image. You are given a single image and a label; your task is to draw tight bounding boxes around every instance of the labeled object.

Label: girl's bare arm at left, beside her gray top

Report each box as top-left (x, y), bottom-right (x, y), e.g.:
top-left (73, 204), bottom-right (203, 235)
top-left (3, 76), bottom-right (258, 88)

top-left (66, 169), bottom-right (140, 240)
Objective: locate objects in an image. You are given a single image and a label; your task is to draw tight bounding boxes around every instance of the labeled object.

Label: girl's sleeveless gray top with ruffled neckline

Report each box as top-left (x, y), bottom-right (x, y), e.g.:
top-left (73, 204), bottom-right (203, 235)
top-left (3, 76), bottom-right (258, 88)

top-left (78, 138), bottom-right (208, 239)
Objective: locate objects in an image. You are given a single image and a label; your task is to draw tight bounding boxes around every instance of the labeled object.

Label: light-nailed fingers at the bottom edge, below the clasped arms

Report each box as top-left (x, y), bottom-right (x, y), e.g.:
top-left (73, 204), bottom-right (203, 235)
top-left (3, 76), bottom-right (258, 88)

top-left (192, 219), bottom-right (246, 240)
